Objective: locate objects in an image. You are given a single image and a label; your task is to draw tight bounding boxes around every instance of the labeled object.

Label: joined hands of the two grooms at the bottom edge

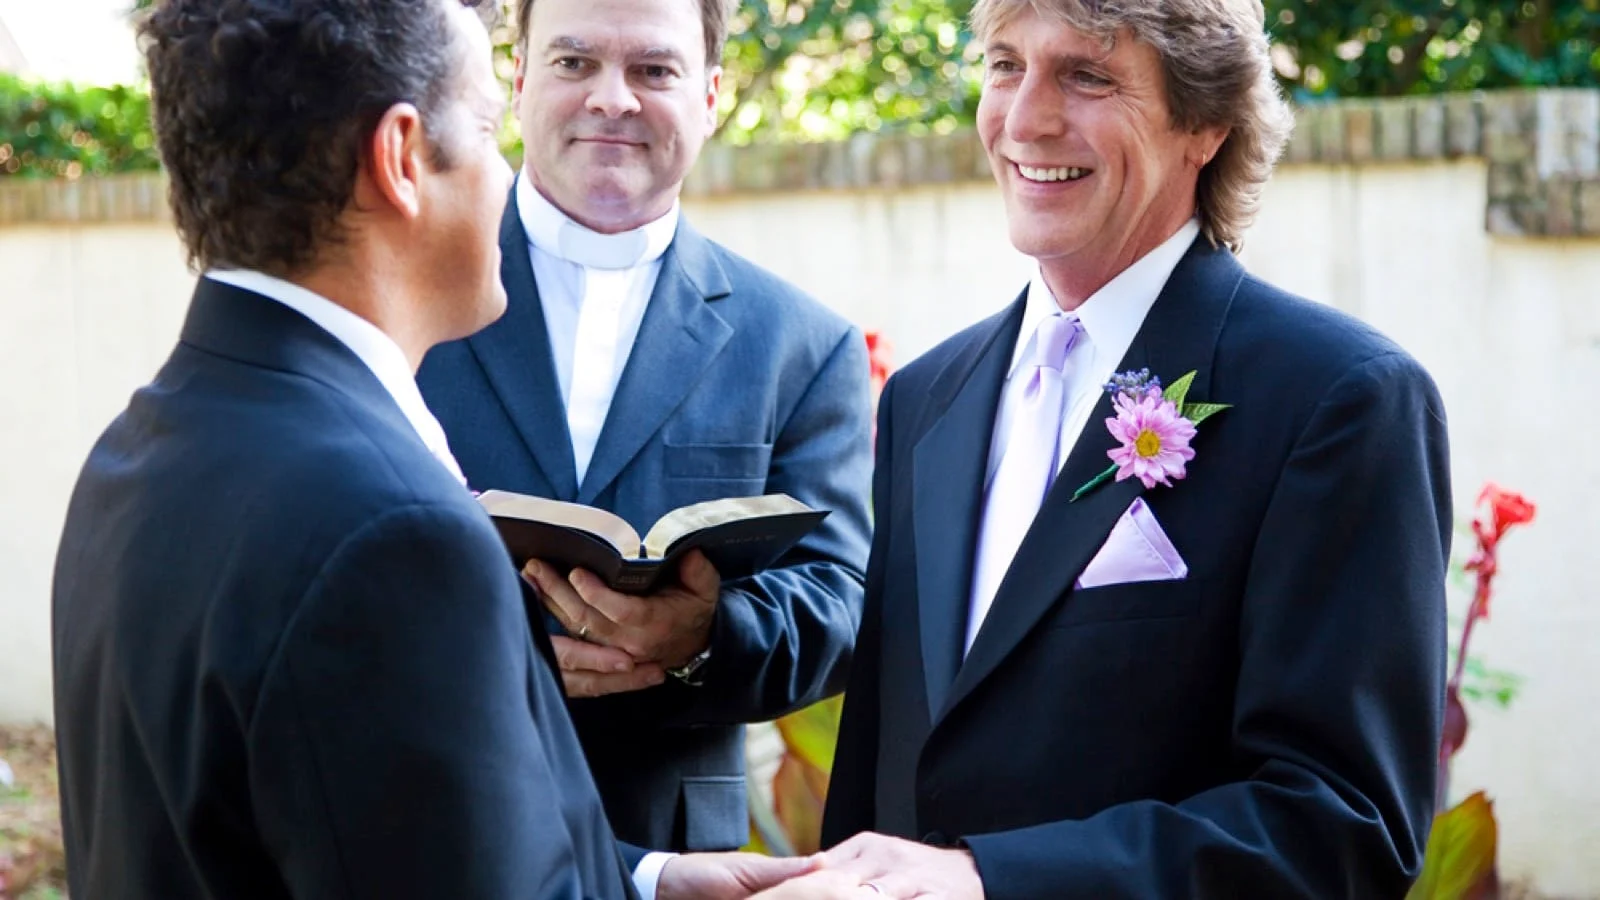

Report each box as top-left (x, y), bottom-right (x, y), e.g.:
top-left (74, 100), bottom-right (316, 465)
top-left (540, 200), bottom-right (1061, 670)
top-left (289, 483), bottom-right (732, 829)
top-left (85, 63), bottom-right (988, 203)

top-left (656, 834), bottom-right (984, 900)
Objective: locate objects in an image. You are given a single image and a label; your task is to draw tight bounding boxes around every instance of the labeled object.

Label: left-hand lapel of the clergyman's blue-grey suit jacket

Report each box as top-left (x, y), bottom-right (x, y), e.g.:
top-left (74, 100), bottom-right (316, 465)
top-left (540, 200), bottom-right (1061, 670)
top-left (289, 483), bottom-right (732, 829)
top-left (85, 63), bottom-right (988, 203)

top-left (467, 192), bottom-right (578, 500)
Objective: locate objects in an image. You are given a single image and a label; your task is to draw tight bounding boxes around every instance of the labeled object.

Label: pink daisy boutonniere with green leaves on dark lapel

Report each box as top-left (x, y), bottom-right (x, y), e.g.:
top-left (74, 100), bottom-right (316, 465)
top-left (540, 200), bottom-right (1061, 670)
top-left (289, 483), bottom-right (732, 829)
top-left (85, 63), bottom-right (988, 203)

top-left (1072, 368), bottom-right (1229, 500)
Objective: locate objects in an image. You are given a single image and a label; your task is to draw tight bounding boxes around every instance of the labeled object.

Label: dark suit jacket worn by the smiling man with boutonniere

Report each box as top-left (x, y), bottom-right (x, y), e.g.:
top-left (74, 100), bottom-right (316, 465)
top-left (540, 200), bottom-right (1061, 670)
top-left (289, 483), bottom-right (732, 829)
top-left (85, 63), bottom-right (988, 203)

top-left (824, 239), bottom-right (1451, 900)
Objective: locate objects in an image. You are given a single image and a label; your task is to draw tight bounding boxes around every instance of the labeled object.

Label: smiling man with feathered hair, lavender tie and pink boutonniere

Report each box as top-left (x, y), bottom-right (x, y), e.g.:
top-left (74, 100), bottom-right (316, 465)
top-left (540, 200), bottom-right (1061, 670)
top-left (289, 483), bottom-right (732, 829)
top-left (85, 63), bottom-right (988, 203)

top-left (824, 0), bottom-right (1451, 900)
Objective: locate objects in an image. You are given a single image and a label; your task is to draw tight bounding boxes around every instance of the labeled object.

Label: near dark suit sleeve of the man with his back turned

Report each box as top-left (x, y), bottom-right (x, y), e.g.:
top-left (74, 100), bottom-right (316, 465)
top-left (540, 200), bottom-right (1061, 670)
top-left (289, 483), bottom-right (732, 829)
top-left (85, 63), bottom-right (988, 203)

top-left (248, 506), bottom-right (622, 900)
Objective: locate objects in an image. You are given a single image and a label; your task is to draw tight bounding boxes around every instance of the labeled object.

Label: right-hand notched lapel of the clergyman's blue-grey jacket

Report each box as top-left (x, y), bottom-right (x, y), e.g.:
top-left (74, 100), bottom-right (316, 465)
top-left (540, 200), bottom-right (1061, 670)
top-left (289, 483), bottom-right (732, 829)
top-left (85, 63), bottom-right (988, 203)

top-left (568, 219), bottom-right (733, 503)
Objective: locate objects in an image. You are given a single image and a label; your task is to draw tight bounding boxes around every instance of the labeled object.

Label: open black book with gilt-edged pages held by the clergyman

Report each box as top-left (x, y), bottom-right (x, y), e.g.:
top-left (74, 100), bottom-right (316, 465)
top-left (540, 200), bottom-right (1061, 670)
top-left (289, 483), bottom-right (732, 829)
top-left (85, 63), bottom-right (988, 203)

top-left (478, 490), bottom-right (827, 594)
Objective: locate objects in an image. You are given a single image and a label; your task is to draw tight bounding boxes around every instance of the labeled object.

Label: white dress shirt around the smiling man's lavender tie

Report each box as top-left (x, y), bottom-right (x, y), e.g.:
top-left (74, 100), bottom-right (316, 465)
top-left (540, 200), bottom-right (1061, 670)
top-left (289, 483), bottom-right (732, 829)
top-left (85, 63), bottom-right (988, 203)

top-left (966, 219), bottom-right (1200, 637)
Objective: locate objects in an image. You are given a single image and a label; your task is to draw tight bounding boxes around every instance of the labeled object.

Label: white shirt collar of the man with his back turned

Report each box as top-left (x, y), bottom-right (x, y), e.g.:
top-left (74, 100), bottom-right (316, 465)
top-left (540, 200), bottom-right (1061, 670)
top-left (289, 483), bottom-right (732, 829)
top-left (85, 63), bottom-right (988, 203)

top-left (205, 269), bottom-right (467, 485)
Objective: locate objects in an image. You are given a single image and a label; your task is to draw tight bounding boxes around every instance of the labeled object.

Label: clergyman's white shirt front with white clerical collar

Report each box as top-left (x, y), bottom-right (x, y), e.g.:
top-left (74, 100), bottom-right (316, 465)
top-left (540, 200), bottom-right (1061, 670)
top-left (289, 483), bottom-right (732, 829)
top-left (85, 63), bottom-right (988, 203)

top-left (517, 173), bottom-right (678, 484)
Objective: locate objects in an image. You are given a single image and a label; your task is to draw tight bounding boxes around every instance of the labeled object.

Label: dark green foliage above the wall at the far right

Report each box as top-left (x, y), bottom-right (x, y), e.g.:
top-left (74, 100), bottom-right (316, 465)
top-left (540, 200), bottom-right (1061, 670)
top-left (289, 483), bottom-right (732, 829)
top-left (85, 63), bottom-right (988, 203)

top-left (1267, 0), bottom-right (1600, 101)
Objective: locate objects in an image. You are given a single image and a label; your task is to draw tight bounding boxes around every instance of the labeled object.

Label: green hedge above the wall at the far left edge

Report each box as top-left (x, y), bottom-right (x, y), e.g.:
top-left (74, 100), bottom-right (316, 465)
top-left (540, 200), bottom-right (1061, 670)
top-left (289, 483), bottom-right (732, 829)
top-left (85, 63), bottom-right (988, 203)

top-left (0, 74), bottom-right (160, 179)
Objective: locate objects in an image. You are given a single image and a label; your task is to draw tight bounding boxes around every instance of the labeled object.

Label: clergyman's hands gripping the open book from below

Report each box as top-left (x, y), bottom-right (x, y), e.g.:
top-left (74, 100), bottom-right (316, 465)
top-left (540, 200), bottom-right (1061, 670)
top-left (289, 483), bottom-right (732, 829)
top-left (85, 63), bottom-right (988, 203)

top-left (522, 551), bottom-right (722, 697)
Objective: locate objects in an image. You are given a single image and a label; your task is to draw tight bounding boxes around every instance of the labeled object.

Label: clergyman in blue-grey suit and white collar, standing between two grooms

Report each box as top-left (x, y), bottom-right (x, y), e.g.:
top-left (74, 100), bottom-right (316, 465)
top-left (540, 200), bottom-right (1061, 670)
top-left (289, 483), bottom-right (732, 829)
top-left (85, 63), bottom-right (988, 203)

top-left (418, 0), bottom-right (870, 850)
